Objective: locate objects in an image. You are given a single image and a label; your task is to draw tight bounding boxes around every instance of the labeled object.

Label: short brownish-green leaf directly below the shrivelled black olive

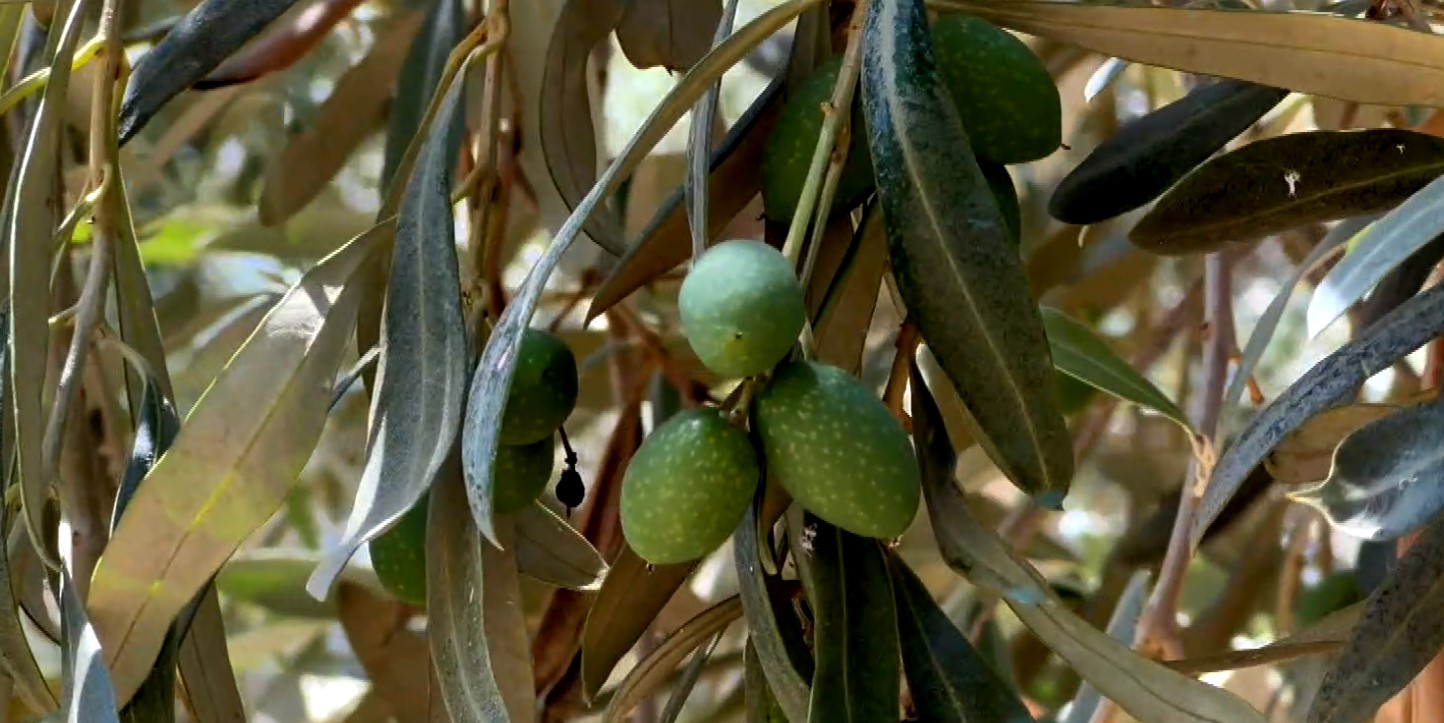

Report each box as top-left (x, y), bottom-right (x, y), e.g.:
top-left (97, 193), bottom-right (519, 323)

top-left (514, 502), bottom-right (606, 590)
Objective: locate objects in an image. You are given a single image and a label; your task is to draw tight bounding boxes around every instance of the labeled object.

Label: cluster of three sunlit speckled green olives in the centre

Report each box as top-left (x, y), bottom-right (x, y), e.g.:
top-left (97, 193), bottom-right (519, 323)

top-left (621, 240), bottom-right (921, 564)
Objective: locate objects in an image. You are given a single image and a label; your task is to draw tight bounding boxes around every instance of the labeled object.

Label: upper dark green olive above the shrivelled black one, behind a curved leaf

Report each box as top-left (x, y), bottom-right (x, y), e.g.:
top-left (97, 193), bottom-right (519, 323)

top-left (501, 329), bottom-right (578, 444)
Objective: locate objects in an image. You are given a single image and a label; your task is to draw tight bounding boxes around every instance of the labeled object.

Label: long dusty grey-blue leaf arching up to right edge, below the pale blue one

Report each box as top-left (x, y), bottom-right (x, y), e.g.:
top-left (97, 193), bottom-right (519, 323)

top-left (1190, 279), bottom-right (1444, 545)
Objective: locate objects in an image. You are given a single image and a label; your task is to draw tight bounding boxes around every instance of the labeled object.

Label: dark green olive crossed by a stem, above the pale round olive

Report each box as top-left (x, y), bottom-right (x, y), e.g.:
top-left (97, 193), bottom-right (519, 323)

top-left (761, 58), bottom-right (874, 222)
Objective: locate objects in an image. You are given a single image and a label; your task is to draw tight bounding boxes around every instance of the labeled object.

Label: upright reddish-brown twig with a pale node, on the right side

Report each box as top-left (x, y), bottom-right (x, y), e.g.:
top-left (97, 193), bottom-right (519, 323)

top-left (1136, 251), bottom-right (1235, 658)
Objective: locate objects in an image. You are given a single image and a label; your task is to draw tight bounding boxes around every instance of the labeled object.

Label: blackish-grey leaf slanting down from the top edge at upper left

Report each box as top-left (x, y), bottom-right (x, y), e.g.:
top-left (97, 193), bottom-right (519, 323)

top-left (120, 0), bottom-right (296, 146)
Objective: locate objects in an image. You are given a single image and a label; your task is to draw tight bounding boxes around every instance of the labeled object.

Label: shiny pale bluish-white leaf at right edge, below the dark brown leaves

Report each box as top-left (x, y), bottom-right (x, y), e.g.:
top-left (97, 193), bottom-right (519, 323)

top-left (1308, 178), bottom-right (1444, 336)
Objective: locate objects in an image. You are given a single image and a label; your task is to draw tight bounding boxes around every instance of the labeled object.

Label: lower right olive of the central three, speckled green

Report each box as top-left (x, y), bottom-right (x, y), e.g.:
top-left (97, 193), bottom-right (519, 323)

top-left (752, 362), bottom-right (923, 538)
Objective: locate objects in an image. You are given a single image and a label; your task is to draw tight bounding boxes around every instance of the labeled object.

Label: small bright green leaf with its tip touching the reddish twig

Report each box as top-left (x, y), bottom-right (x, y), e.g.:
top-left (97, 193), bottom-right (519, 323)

top-left (1040, 306), bottom-right (1191, 429)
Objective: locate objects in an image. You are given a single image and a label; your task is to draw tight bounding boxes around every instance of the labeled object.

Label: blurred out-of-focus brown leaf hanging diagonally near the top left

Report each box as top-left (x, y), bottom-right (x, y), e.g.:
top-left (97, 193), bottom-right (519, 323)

top-left (257, 9), bottom-right (426, 225)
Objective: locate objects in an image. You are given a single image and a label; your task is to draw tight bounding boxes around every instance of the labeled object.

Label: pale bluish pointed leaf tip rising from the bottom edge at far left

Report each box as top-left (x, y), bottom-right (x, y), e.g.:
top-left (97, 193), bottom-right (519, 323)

top-left (61, 571), bottom-right (120, 723)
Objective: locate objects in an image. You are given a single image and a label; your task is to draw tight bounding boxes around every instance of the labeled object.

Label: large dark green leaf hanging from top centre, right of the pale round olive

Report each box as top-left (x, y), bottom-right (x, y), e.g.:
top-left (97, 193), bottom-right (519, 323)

top-left (862, 0), bottom-right (1073, 508)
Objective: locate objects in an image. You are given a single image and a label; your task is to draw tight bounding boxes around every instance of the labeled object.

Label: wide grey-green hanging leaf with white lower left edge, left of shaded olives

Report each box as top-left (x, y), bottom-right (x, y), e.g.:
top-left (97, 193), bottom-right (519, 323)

top-left (306, 84), bottom-right (471, 599)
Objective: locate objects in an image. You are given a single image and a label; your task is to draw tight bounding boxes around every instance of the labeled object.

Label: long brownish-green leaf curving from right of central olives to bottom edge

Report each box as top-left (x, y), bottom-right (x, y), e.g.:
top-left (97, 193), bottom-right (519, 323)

top-left (911, 367), bottom-right (1264, 723)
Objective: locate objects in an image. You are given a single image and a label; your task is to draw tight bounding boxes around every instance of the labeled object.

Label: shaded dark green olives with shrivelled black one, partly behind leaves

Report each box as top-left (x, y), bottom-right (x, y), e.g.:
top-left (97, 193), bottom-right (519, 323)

top-left (370, 329), bottom-right (580, 606)
